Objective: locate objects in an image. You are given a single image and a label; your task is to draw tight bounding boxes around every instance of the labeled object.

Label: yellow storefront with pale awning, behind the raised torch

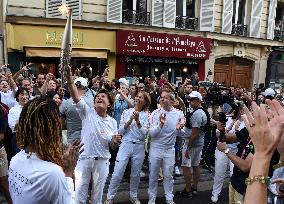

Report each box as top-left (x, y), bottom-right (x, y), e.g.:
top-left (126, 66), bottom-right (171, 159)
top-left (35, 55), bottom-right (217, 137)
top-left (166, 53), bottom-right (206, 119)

top-left (6, 23), bottom-right (116, 78)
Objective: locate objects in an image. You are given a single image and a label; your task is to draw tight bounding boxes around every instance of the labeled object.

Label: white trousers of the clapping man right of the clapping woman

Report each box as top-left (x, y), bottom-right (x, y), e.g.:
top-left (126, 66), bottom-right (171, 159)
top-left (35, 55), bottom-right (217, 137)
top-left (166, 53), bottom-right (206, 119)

top-left (148, 146), bottom-right (175, 200)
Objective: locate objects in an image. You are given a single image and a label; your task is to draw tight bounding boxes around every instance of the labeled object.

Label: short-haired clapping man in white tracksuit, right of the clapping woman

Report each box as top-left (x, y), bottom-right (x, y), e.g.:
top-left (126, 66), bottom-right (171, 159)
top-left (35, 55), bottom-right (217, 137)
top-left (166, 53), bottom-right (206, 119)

top-left (148, 90), bottom-right (185, 204)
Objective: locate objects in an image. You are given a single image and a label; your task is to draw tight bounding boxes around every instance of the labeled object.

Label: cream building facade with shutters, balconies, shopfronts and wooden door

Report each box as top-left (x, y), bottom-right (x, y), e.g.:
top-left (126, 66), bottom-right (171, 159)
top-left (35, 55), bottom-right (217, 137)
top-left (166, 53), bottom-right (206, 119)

top-left (3, 0), bottom-right (284, 89)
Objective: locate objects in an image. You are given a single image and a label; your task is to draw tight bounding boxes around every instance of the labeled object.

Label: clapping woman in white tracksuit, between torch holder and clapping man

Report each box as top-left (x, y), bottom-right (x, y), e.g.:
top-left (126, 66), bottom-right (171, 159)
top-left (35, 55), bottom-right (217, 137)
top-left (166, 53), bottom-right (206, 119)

top-left (105, 91), bottom-right (151, 204)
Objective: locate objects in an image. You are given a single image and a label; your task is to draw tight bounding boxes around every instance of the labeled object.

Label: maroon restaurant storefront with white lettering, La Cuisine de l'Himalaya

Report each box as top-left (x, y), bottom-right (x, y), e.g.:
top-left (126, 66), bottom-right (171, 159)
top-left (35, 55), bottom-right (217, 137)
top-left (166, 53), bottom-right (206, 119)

top-left (116, 30), bottom-right (211, 83)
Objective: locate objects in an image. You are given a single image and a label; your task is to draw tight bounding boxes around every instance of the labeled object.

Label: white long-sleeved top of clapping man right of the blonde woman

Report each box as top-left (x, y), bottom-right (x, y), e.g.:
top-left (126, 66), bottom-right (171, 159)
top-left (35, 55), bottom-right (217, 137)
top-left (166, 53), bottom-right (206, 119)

top-left (149, 108), bottom-right (185, 148)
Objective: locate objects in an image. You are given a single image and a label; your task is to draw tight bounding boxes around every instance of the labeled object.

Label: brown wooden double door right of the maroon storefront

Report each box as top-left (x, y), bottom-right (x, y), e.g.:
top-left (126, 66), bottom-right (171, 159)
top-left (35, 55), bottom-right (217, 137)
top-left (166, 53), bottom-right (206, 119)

top-left (214, 58), bottom-right (252, 89)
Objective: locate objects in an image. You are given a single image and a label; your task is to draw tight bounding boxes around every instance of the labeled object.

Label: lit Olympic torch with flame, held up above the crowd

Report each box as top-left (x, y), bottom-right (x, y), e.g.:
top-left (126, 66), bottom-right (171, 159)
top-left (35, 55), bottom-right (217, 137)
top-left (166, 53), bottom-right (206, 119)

top-left (58, 5), bottom-right (72, 87)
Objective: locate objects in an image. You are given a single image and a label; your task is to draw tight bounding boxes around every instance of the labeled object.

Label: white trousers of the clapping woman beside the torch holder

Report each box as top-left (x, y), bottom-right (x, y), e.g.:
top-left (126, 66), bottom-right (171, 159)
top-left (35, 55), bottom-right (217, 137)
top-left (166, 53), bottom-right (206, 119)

top-left (107, 142), bottom-right (145, 199)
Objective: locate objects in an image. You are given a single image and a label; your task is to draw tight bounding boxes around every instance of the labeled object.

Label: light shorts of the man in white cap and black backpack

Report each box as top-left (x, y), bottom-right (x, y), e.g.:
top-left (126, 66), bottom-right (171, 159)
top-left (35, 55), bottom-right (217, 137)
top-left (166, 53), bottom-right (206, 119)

top-left (181, 139), bottom-right (203, 167)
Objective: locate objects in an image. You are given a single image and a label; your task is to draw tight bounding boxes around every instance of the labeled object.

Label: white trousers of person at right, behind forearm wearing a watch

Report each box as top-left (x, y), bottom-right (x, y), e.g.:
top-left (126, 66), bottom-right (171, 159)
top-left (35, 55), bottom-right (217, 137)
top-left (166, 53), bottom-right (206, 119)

top-left (212, 148), bottom-right (234, 197)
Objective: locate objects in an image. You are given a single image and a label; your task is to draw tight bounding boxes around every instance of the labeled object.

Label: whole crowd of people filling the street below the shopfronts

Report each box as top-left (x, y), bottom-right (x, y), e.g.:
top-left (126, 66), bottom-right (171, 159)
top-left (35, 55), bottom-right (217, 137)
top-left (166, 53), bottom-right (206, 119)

top-left (0, 62), bottom-right (284, 204)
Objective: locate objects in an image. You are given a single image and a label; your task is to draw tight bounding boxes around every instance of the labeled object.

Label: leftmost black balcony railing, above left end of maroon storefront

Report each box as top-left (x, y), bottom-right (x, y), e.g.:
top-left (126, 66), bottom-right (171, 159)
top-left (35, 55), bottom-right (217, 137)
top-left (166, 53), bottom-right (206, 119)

top-left (122, 9), bottom-right (150, 25)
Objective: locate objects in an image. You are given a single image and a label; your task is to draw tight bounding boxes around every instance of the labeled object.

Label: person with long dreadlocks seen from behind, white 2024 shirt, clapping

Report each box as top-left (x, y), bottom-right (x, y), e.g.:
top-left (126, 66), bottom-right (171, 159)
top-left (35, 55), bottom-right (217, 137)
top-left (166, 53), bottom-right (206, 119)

top-left (9, 97), bottom-right (82, 204)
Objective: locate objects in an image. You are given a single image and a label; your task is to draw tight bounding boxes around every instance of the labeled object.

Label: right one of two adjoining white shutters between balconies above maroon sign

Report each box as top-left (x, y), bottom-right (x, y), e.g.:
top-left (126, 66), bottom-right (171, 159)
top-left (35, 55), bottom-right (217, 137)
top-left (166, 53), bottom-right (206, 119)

top-left (163, 0), bottom-right (176, 28)
